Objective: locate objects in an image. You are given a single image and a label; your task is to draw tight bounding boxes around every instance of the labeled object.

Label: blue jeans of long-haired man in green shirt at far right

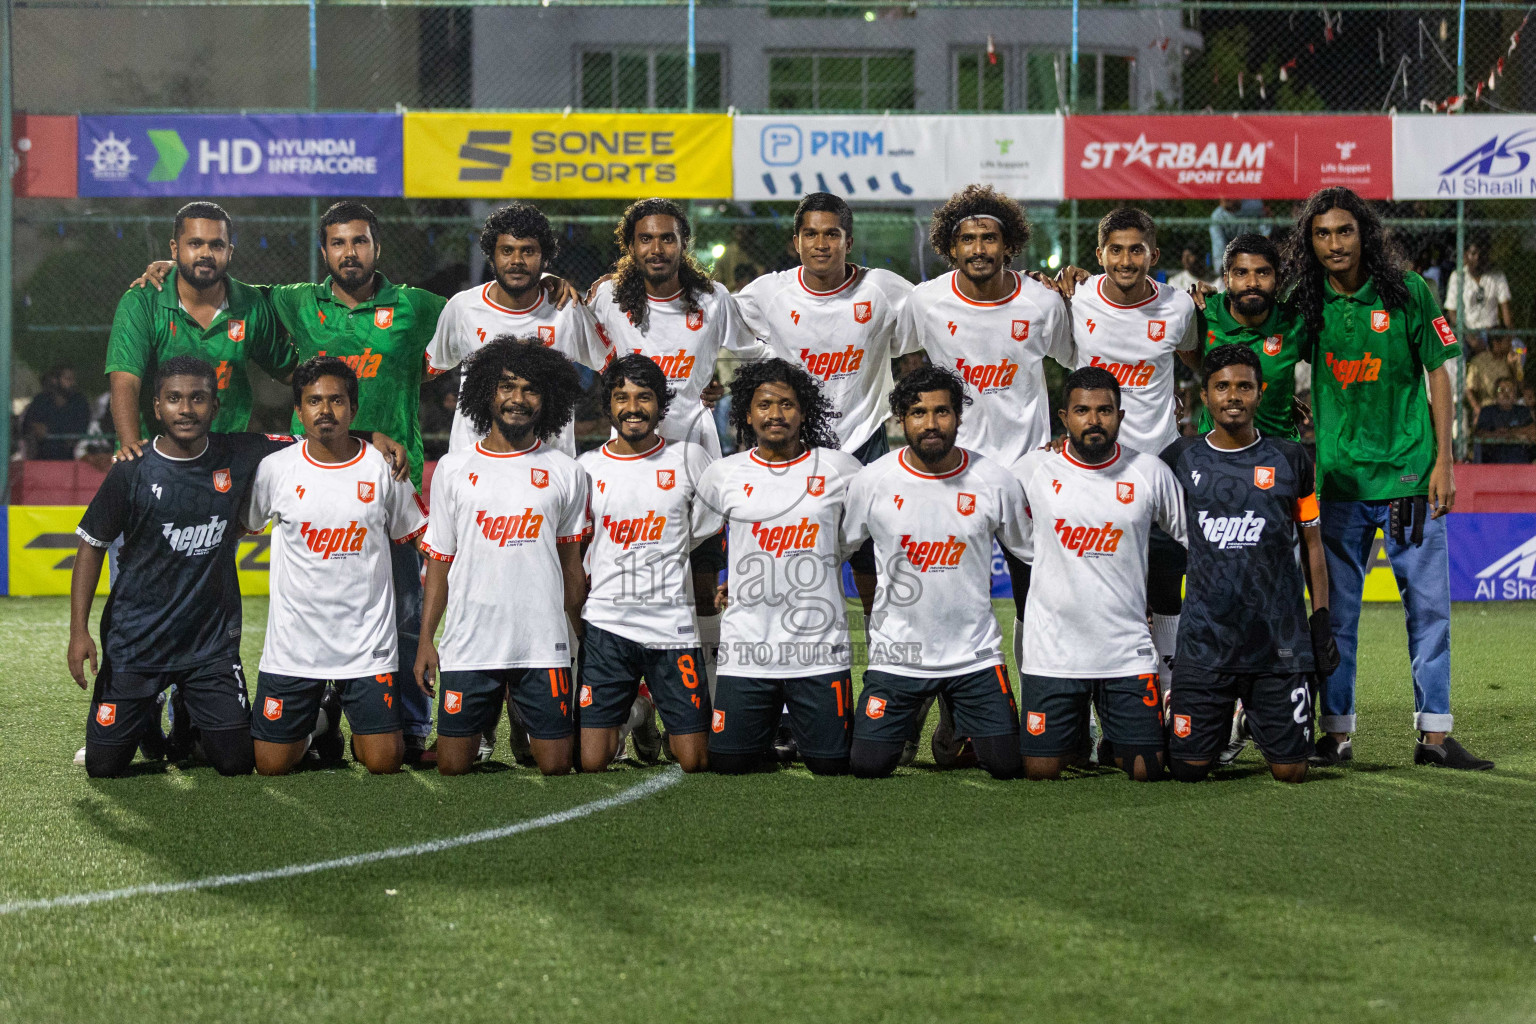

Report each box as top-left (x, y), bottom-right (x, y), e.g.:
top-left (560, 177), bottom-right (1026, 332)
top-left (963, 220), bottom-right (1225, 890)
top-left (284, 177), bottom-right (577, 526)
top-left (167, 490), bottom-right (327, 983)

top-left (1319, 502), bottom-right (1452, 732)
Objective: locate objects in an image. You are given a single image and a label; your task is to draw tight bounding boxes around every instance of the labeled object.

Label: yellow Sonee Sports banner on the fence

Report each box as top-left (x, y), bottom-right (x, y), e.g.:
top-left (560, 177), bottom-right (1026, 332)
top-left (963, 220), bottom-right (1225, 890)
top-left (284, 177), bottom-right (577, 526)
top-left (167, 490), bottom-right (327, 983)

top-left (406, 112), bottom-right (733, 200)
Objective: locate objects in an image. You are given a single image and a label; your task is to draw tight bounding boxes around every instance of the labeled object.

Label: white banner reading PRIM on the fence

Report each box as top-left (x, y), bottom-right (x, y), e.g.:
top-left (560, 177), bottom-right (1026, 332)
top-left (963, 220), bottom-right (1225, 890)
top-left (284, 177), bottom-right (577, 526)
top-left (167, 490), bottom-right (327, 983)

top-left (733, 114), bottom-right (1063, 203)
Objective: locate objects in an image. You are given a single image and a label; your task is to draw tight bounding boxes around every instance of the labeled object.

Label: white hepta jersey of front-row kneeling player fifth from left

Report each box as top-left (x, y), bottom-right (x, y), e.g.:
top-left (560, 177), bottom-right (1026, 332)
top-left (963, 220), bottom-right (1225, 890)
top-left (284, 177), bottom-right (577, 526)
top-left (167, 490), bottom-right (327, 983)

top-left (699, 448), bottom-right (860, 679)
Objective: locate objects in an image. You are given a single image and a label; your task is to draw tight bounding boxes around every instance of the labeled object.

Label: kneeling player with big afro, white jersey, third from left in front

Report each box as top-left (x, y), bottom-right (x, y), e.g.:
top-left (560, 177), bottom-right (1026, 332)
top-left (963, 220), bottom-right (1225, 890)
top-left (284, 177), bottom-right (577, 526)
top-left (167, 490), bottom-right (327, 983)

top-left (415, 338), bottom-right (591, 775)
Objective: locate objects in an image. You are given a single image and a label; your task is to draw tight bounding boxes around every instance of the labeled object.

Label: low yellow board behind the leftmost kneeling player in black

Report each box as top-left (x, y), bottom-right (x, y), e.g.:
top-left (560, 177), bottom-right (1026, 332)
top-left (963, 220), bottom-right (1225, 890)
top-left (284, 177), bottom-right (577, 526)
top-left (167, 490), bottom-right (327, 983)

top-left (6, 505), bottom-right (272, 597)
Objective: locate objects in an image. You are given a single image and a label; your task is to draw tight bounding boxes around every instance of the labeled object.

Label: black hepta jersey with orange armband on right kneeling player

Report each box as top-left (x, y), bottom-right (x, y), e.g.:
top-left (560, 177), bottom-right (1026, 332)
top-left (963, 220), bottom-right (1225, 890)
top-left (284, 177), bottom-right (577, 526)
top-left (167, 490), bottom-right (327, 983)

top-left (1163, 436), bottom-right (1318, 672)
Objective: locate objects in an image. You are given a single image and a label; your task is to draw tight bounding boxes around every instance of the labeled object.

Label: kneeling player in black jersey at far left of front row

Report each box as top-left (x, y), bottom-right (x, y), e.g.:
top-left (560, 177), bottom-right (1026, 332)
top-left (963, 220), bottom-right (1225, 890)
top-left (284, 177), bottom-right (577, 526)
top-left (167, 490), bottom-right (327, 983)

top-left (69, 356), bottom-right (293, 778)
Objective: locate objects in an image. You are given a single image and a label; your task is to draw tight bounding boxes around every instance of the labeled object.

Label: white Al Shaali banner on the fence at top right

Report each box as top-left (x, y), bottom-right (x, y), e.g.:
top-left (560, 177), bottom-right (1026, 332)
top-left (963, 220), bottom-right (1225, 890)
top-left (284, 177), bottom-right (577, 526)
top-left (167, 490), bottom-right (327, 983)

top-left (1392, 114), bottom-right (1536, 200)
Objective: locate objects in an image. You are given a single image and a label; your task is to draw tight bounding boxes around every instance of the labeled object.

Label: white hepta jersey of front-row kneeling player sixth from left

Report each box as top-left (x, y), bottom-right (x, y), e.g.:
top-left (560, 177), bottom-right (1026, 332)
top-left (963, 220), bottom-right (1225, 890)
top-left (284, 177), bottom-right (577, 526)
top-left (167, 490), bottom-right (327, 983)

top-left (843, 448), bottom-right (1028, 679)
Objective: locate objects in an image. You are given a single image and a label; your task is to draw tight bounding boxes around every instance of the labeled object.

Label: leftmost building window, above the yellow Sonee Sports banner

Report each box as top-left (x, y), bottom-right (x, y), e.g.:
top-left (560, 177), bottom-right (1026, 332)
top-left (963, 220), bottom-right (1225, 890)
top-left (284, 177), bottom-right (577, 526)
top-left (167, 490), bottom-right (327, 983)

top-left (581, 49), bottom-right (725, 111)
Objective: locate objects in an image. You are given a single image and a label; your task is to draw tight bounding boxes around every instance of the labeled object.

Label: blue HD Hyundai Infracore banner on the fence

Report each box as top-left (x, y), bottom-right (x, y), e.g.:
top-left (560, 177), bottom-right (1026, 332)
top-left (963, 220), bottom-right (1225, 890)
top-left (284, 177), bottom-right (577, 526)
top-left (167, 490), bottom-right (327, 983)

top-left (78, 114), bottom-right (401, 197)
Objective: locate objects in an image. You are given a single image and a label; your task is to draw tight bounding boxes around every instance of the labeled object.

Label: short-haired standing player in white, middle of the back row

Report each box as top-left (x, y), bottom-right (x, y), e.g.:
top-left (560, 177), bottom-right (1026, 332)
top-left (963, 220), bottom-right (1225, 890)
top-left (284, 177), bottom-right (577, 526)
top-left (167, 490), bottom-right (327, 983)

top-left (736, 192), bottom-right (912, 613)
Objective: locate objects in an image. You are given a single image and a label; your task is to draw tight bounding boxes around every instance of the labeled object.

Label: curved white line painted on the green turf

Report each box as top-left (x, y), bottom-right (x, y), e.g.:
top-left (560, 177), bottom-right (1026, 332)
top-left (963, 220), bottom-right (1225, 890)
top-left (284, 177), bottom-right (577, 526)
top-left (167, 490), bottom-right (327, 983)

top-left (0, 765), bottom-right (682, 917)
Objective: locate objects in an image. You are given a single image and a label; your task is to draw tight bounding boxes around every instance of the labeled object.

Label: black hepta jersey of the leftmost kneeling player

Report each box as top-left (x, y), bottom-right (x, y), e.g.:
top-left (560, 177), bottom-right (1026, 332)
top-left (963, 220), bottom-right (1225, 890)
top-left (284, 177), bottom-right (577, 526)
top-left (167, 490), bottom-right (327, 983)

top-left (75, 433), bottom-right (293, 672)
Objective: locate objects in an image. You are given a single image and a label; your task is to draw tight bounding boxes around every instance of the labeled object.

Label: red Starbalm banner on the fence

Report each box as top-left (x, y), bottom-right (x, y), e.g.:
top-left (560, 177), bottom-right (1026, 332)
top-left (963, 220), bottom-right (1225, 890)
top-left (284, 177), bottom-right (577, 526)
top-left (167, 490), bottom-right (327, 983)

top-left (1066, 114), bottom-right (1392, 201)
